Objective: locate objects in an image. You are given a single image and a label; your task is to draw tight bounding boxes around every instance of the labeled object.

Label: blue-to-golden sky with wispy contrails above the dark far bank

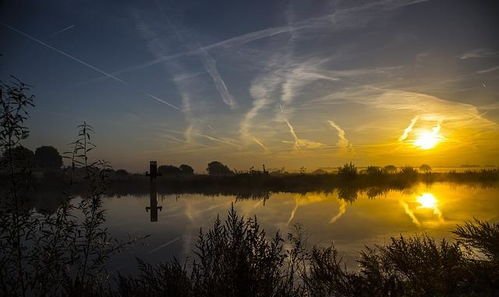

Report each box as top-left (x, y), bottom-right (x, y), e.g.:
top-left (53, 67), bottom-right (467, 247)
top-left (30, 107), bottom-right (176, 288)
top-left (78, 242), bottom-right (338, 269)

top-left (0, 0), bottom-right (499, 172)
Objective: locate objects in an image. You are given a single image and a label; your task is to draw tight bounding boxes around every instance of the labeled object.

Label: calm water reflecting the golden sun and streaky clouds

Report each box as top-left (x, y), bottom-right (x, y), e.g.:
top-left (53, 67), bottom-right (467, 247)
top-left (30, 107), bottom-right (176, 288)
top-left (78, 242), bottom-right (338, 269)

top-left (104, 183), bottom-right (499, 272)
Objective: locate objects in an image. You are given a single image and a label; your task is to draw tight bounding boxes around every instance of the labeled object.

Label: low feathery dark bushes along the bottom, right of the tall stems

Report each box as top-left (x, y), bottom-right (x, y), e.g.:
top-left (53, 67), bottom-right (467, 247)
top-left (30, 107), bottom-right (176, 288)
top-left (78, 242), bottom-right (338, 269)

top-left (118, 209), bottom-right (499, 297)
